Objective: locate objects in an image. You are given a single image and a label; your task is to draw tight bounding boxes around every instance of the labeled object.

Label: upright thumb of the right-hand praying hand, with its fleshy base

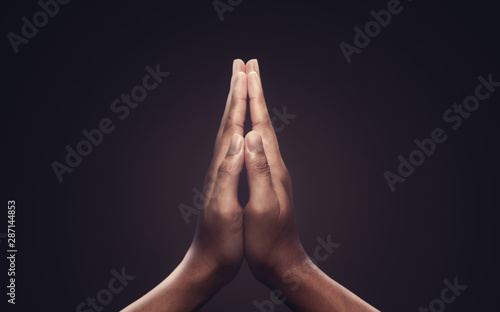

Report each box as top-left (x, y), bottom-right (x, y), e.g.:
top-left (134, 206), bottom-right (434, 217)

top-left (245, 131), bottom-right (279, 215)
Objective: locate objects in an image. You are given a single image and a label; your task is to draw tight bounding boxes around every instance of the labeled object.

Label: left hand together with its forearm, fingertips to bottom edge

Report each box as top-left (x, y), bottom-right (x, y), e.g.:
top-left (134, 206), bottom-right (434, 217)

top-left (123, 60), bottom-right (247, 312)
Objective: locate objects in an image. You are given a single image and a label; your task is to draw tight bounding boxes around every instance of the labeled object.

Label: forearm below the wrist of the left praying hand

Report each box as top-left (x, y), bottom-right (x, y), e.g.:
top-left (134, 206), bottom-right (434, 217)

top-left (123, 252), bottom-right (224, 312)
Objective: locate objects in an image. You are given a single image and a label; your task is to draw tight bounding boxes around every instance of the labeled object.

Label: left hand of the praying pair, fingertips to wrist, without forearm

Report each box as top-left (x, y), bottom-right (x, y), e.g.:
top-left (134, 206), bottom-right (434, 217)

top-left (188, 60), bottom-right (247, 285)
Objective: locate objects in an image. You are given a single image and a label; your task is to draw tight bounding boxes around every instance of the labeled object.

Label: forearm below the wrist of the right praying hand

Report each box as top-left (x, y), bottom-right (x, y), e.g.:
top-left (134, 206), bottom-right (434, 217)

top-left (267, 258), bottom-right (378, 312)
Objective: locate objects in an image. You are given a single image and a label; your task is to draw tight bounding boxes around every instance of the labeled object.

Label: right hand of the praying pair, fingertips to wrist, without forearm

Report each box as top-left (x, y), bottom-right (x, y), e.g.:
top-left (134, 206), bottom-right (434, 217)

top-left (244, 60), bottom-right (308, 285)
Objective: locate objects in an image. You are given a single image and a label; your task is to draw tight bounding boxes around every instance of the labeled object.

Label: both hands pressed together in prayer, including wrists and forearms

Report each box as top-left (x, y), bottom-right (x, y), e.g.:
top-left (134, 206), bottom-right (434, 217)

top-left (123, 60), bottom-right (377, 312)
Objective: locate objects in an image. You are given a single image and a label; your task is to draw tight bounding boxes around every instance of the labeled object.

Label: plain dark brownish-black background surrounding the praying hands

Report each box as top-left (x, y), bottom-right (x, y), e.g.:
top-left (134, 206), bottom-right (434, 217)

top-left (0, 0), bottom-right (500, 312)
